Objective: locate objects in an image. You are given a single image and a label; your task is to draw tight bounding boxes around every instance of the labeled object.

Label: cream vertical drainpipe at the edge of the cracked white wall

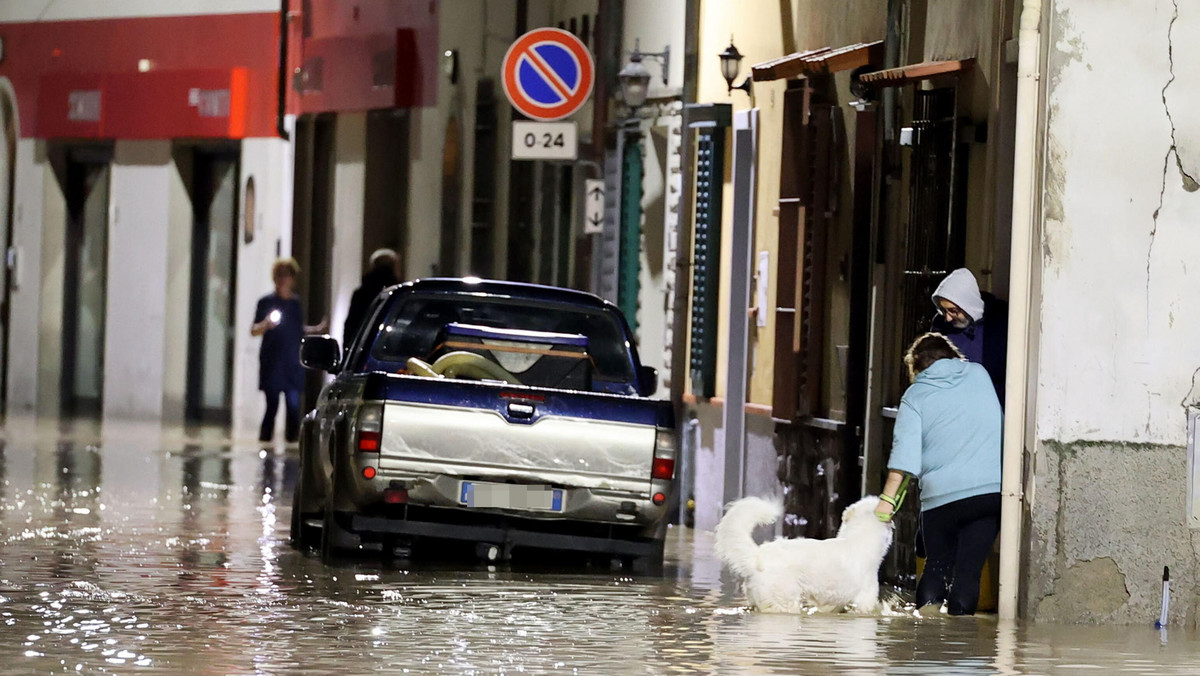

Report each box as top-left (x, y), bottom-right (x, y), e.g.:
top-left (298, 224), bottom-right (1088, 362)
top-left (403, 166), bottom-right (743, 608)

top-left (998, 0), bottom-right (1042, 620)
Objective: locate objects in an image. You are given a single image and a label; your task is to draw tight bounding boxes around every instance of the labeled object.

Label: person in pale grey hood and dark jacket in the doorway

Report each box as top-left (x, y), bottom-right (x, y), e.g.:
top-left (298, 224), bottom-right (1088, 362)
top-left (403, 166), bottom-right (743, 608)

top-left (929, 268), bottom-right (1008, 406)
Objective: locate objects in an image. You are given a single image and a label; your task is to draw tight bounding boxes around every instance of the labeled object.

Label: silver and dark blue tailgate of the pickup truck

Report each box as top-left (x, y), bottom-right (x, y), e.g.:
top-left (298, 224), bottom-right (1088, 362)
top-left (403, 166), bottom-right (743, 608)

top-left (369, 376), bottom-right (664, 491)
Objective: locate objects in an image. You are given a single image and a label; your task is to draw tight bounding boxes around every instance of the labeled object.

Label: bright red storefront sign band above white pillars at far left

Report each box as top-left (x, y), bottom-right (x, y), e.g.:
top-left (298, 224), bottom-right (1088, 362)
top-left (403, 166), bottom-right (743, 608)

top-left (0, 13), bottom-right (280, 139)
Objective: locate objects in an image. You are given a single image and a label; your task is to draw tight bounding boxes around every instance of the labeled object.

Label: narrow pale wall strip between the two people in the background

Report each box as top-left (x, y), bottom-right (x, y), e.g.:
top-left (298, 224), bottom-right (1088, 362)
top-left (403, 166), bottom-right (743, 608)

top-left (329, 113), bottom-right (367, 348)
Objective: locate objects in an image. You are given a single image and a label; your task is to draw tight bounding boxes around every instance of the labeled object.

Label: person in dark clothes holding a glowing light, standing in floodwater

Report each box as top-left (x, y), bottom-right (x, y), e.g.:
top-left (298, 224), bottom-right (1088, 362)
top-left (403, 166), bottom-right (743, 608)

top-left (250, 258), bottom-right (329, 443)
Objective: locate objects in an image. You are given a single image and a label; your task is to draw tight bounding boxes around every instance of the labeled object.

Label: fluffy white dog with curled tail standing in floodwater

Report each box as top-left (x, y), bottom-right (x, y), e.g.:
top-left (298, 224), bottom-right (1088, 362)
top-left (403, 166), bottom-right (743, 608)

top-left (716, 496), bottom-right (892, 612)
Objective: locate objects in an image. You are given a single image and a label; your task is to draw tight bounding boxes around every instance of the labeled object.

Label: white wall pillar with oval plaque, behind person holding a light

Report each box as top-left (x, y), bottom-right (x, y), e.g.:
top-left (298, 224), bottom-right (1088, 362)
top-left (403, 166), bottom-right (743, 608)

top-left (233, 136), bottom-right (293, 438)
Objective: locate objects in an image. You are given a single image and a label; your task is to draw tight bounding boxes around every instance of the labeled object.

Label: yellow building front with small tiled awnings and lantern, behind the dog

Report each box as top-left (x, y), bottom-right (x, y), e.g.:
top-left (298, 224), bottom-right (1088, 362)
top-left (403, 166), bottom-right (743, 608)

top-left (688, 1), bottom-right (1015, 549)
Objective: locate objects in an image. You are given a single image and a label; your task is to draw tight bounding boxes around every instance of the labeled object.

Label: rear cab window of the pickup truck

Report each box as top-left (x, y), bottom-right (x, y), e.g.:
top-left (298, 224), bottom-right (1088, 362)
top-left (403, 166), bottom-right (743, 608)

top-left (370, 294), bottom-right (635, 394)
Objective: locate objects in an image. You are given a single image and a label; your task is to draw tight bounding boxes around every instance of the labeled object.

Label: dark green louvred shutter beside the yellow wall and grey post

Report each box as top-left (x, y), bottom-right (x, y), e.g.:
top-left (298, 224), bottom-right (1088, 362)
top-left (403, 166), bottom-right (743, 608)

top-left (691, 127), bottom-right (725, 397)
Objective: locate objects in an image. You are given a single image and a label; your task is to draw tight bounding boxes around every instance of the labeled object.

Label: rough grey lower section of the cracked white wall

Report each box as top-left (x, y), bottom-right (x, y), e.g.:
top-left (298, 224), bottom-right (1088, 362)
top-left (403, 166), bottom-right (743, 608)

top-left (1025, 442), bottom-right (1200, 628)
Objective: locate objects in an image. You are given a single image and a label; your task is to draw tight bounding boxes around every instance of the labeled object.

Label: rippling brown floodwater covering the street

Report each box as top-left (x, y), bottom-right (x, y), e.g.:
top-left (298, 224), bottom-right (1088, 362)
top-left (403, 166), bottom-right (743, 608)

top-left (0, 427), bottom-right (1200, 676)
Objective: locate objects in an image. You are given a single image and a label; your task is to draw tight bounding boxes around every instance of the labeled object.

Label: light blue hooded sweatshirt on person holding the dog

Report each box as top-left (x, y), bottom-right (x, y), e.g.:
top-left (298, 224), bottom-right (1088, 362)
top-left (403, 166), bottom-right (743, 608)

top-left (888, 359), bottom-right (1003, 512)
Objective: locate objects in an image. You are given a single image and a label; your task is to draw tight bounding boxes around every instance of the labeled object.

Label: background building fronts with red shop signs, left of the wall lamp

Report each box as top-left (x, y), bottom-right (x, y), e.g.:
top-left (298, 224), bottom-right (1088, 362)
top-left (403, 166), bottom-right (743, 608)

top-left (0, 0), bottom-right (638, 437)
